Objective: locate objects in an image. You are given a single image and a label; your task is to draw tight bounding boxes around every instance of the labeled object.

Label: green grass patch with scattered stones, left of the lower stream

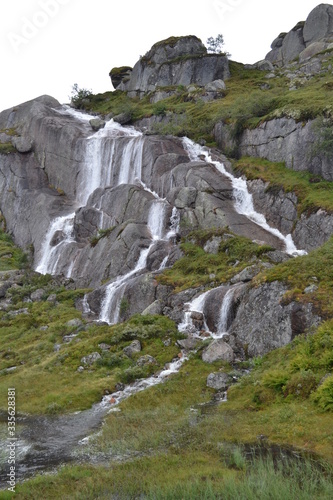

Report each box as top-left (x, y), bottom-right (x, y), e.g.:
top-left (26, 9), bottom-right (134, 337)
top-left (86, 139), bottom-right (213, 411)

top-left (0, 292), bottom-right (179, 413)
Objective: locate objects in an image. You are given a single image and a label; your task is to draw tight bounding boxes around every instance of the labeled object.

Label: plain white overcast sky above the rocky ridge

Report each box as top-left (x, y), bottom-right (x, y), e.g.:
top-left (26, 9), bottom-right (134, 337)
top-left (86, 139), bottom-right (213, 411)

top-left (0, 0), bottom-right (326, 111)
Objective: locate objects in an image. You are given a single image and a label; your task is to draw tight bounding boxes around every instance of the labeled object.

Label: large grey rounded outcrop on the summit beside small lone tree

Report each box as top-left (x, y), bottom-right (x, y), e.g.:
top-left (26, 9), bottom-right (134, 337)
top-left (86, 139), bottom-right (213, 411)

top-left (110, 36), bottom-right (230, 96)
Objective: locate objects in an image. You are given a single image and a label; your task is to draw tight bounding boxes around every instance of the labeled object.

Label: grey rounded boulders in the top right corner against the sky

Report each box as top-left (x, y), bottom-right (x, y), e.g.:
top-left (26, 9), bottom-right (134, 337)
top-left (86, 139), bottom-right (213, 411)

top-left (266, 4), bottom-right (333, 66)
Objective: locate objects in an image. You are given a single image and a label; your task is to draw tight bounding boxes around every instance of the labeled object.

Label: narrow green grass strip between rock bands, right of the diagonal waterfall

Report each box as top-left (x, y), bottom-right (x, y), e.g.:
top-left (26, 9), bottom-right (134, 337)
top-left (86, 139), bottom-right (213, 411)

top-left (234, 157), bottom-right (333, 215)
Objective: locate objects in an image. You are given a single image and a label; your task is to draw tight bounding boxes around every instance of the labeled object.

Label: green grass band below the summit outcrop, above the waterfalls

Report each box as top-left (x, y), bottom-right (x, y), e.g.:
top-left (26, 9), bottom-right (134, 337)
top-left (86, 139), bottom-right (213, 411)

top-left (78, 54), bottom-right (333, 145)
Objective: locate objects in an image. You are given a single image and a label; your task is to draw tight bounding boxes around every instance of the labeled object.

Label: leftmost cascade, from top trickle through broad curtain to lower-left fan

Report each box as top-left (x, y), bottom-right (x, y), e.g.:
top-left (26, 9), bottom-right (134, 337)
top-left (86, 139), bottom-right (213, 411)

top-left (35, 106), bottom-right (143, 277)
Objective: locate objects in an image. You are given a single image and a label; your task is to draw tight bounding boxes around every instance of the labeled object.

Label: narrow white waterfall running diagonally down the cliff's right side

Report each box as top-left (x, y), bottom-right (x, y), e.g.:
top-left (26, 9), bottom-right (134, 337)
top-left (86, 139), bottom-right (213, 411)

top-left (183, 137), bottom-right (306, 256)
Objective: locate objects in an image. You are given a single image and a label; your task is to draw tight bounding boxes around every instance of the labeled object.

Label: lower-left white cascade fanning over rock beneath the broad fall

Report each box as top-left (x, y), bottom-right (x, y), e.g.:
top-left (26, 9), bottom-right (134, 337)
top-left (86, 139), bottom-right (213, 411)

top-left (36, 213), bottom-right (75, 274)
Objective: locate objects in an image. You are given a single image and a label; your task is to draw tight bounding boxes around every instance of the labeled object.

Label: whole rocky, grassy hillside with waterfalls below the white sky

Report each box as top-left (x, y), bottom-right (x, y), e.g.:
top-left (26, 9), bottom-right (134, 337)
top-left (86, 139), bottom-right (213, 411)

top-left (0, 4), bottom-right (333, 499)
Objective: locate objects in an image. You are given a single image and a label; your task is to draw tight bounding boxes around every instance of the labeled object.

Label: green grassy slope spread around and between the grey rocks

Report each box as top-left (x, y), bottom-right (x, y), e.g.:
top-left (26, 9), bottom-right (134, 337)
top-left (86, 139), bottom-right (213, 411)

top-left (0, 55), bottom-right (333, 499)
